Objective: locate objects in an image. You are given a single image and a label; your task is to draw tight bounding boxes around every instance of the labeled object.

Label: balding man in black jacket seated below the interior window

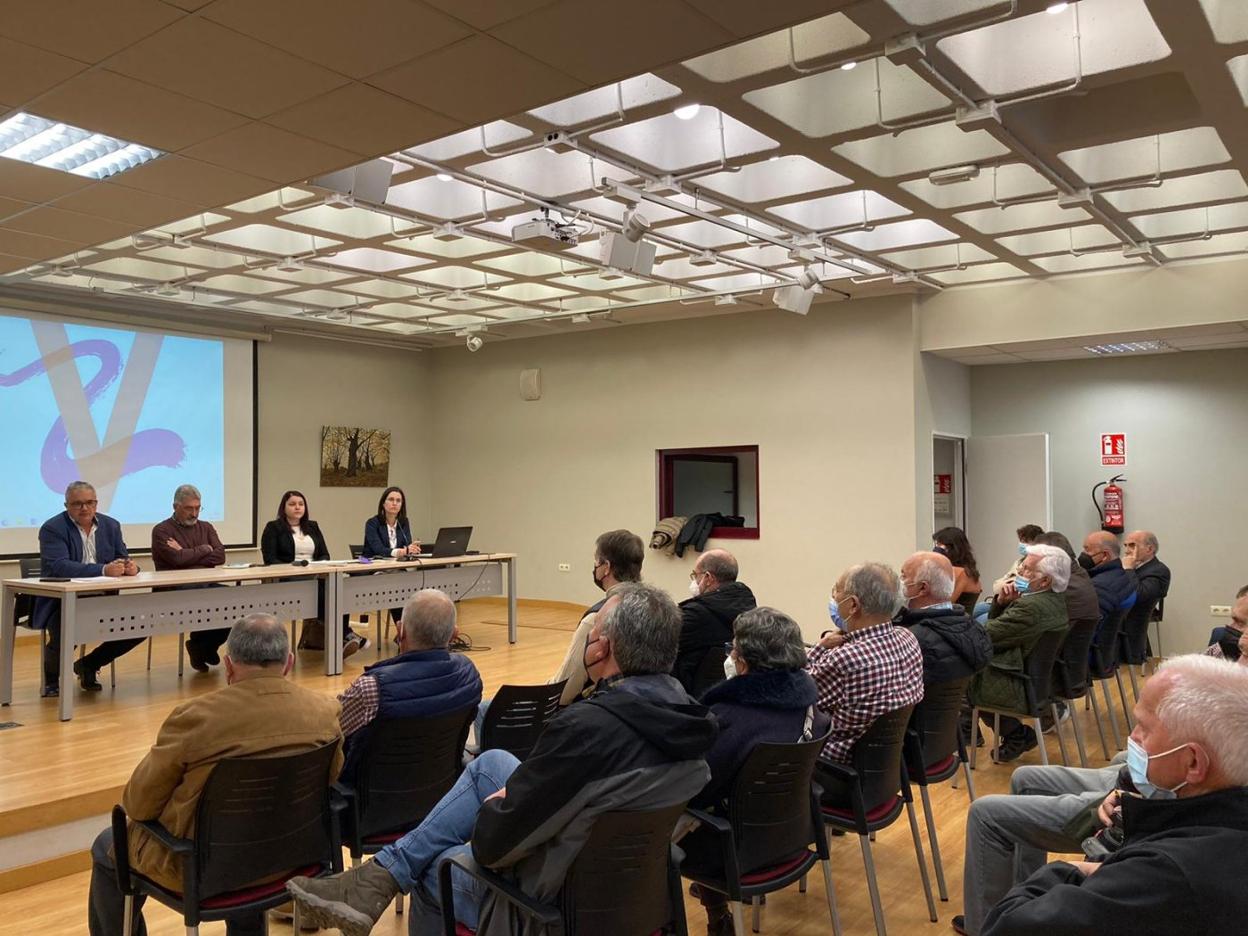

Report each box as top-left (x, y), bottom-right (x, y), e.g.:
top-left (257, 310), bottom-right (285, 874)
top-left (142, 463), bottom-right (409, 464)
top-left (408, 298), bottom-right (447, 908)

top-left (671, 549), bottom-right (758, 693)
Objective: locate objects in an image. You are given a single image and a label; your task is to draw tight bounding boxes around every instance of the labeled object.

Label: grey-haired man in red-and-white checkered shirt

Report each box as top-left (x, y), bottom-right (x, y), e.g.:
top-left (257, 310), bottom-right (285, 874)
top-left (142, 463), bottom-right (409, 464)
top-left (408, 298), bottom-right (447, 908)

top-left (806, 563), bottom-right (924, 788)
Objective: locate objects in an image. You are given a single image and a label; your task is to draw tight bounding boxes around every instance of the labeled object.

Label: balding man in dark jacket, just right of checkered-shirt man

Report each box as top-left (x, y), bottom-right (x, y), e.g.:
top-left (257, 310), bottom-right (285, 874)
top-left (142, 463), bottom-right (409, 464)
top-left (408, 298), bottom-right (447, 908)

top-left (896, 553), bottom-right (992, 685)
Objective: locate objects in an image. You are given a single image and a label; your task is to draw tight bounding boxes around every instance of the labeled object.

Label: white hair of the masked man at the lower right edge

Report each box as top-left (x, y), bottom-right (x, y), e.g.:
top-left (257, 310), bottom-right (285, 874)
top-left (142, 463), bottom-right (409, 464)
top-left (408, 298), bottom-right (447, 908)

top-left (1157, 653), bottom-right (1248, 786)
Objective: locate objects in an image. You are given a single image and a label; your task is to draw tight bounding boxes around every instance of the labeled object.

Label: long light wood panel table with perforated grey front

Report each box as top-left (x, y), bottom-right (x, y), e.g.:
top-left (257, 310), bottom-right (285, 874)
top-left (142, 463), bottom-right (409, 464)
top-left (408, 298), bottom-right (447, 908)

top-left (0, 553), bottom-right (517, 721)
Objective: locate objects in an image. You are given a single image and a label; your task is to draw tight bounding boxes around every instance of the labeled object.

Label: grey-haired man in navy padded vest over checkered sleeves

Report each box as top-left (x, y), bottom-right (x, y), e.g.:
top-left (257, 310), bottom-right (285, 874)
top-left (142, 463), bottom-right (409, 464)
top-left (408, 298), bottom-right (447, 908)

top-left (338, 588), bottom-right (480, 782)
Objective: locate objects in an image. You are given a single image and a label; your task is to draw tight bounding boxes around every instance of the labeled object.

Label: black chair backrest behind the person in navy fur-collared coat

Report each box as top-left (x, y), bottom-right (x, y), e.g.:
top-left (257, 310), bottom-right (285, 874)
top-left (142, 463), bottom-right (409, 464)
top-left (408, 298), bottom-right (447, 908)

top-left (728, 735), bottom-right (827, 874)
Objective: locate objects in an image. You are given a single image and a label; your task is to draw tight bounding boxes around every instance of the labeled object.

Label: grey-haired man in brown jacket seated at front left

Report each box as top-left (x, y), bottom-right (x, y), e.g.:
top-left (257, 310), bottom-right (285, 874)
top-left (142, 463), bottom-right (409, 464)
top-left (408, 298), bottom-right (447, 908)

top-left (87, 614), bottom-right (342, 936)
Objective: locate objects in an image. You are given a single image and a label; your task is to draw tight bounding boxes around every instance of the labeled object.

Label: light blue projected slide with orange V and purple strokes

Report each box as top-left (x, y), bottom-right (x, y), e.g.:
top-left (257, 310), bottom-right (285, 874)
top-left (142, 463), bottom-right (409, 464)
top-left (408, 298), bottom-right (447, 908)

top-left (0, 316), bottom-right (225, 529)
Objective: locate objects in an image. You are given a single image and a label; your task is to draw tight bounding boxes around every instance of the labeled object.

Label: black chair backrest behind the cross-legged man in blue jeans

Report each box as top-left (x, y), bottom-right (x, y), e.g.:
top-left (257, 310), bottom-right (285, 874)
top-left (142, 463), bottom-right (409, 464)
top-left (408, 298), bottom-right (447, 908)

top-left (560, 802), bottom-right (685, 936)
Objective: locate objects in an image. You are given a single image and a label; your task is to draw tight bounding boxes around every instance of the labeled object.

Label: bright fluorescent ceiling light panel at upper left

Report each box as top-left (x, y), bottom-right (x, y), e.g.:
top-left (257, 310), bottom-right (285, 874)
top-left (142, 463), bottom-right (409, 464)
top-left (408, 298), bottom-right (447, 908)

top-left (0, 112), bottom-right (165, 178)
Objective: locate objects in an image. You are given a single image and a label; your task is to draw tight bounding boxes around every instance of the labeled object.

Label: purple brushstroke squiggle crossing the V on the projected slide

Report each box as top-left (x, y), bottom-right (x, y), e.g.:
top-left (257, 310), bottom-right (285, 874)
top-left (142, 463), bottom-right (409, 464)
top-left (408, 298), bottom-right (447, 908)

top-left (0, 339), bottom-right (186, 493)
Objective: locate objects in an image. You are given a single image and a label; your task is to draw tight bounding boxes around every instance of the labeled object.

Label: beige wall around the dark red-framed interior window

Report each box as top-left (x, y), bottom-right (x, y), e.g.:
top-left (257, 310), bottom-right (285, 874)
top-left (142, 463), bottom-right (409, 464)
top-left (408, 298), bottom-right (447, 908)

top-left (432, 297), bottom-right (931, 634)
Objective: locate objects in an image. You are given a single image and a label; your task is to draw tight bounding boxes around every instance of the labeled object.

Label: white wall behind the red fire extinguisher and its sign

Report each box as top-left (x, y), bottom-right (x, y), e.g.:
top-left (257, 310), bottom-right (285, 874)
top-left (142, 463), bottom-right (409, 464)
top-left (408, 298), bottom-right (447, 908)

top-left (971, 349), bottom-right (1248, 653)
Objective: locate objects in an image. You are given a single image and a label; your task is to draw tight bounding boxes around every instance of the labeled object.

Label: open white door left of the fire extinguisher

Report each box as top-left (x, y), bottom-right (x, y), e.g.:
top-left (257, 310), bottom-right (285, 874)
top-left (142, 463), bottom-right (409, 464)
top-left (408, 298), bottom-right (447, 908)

top-left (966, 433), bottom-right (1053, 592)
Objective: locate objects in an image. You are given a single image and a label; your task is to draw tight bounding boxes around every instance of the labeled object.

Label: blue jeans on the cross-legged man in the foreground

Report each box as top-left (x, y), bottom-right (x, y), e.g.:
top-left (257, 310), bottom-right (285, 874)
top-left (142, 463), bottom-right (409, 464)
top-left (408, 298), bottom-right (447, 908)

top-left (374, 750), bottom-right (520, 936)
